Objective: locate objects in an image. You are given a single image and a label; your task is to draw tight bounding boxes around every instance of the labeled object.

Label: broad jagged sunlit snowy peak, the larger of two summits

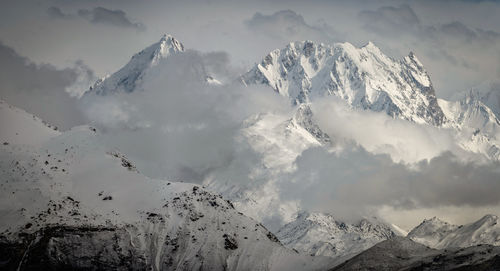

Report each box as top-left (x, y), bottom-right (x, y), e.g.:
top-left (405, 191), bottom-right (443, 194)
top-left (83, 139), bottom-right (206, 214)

top-left (242, 41), bottom-right (445, 126)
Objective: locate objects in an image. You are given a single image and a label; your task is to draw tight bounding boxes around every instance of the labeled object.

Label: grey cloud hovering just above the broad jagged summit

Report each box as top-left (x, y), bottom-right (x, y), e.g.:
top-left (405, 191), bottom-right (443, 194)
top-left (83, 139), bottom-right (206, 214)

top-left (245, 9), bottom-right (335, 42)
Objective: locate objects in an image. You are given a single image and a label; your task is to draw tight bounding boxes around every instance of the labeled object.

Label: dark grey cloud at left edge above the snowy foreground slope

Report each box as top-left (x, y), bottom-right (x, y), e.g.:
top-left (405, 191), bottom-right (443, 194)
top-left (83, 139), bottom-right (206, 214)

top-left (0, 44), bottom-right (92, 129)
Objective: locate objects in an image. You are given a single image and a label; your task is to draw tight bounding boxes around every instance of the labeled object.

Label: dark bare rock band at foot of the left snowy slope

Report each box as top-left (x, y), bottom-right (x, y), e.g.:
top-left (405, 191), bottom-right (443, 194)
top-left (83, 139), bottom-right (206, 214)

top-left (0, 226), bottom-right (149, 270)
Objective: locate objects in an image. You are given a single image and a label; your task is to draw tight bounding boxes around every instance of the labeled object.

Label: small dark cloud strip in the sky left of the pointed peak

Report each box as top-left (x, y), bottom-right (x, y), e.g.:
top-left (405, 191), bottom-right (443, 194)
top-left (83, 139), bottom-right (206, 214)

top-left (78, 7), bottom-right (145, 31)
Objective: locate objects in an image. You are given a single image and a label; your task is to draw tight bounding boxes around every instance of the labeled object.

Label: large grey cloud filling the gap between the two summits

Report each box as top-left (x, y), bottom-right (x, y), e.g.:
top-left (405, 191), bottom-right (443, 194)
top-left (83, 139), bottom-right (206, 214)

top-left (82, 51), bottom-right (289, 184)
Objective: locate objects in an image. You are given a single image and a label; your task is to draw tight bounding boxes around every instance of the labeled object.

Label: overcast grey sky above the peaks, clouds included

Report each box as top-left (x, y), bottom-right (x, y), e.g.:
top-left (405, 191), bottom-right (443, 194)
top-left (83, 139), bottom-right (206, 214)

top-left (0, 0), bottom-right (500, 98)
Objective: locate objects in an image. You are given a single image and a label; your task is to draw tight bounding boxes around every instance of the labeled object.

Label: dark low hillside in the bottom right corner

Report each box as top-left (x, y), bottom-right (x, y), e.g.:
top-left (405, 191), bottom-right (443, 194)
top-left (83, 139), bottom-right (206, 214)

top-left (331, 237), bottom-right (500, 270)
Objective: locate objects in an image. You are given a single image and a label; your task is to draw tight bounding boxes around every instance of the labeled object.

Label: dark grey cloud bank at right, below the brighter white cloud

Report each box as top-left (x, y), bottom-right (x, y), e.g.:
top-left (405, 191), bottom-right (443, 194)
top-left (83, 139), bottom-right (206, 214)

top-left (281, 147), bottom-right (500, 221)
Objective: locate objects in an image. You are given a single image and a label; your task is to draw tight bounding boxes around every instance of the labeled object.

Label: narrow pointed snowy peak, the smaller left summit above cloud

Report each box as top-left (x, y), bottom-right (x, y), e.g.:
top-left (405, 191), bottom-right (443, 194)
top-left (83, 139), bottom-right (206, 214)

top-left (90, 35), bottom-right (184, 95)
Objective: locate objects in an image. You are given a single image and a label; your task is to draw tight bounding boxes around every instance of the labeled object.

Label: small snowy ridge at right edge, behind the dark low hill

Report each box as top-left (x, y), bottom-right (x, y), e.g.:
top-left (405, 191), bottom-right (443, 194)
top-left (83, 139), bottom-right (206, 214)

top-left (408, 215), bottom-right (500, 249)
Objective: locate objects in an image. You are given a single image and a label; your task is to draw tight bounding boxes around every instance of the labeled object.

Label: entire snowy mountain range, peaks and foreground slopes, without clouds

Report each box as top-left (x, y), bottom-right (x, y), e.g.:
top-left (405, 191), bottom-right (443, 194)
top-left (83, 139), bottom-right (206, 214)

top-left (0, 35), bottom-right (500, 270)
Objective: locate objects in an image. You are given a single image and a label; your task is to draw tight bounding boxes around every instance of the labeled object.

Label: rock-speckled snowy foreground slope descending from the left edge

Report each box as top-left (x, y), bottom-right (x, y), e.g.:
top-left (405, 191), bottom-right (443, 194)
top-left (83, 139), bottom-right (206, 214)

top-left (0, 102), bottom-right (331, 270)
